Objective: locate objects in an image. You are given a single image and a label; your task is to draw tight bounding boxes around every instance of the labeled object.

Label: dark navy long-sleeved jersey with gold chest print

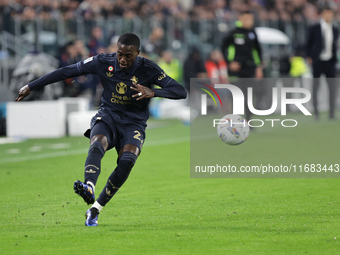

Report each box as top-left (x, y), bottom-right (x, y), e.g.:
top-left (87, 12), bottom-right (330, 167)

top-left (28, 53), bottom-right (186, 123)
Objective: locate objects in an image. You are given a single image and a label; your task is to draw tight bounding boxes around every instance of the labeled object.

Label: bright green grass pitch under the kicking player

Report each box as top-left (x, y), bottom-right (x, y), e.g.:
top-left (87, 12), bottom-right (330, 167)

top-left (0, 116), bottom-right (340, 255)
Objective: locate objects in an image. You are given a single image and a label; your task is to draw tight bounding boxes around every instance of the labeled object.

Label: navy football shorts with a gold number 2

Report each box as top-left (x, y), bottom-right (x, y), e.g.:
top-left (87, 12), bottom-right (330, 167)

top-left (84, 109), bottom-right (146, 153)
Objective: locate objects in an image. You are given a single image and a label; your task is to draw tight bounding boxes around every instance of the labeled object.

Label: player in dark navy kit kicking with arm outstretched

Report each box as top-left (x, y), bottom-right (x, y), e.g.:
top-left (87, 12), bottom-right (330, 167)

top-left (15, 33), bottom-right (187, 226)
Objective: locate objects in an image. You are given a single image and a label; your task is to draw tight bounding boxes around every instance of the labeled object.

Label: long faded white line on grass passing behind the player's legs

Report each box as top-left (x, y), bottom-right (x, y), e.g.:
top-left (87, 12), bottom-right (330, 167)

top-left (0, 137), bottom-right (190, 164)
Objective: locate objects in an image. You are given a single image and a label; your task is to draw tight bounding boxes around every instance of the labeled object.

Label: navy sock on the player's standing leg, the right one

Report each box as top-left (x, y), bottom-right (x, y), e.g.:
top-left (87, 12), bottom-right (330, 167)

top-left (97, 151), bottom-right (137, 206)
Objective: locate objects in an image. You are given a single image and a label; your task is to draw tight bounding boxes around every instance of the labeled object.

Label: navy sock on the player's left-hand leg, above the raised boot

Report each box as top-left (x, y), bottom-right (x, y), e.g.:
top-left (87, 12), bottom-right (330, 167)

top-left (84, 141), bottom-right (105, 188)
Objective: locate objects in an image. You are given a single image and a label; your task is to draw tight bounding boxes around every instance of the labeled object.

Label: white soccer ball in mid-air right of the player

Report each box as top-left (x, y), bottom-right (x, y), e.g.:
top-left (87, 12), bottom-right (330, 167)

top-left (217, 114), bottom-right (249, 145)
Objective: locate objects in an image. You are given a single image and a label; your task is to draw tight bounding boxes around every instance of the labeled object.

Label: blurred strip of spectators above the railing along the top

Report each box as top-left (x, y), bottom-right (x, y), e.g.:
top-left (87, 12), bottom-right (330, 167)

top-left (0, 0), bottom-right (340, 26)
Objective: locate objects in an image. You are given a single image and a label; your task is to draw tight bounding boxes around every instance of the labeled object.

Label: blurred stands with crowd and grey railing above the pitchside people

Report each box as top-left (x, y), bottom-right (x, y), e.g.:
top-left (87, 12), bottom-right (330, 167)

top-left (0, 0), bottom-right (340, 87)
